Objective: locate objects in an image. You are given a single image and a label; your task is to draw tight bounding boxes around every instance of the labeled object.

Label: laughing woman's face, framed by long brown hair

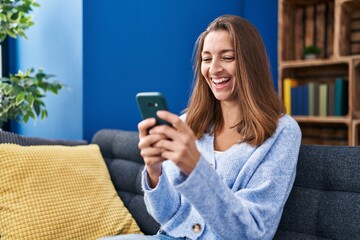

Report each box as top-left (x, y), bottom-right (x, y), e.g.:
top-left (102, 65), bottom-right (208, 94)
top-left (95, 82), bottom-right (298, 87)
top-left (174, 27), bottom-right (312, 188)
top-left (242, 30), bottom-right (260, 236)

top-left (201, 30), bottom-right (236, 101)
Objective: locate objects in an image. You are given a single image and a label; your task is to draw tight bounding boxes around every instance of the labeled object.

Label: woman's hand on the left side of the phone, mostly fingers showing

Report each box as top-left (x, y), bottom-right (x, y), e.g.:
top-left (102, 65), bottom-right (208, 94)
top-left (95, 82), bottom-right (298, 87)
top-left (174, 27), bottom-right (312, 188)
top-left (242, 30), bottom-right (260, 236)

top-left (138, 118), bottom-right (166, 188)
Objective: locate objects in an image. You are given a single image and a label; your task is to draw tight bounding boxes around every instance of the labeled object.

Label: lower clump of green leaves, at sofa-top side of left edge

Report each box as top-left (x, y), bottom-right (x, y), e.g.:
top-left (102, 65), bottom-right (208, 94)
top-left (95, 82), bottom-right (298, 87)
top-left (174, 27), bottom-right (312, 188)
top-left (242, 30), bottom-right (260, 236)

top-left (0, 69), bottom-right (63, 127)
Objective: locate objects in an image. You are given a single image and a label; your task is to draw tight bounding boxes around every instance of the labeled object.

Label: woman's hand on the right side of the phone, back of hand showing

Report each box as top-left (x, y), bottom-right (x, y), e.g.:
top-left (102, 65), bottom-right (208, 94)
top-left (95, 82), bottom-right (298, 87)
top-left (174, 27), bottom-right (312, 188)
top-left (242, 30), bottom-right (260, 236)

top-left (149, 111), bottom-right (200, 175)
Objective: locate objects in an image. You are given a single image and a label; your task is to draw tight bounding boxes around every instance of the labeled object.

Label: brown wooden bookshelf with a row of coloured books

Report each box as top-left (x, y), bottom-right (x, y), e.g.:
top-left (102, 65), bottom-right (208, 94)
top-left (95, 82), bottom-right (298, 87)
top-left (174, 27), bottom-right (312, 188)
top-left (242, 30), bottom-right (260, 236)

top-left (278, 0), bottom-right (360, 145)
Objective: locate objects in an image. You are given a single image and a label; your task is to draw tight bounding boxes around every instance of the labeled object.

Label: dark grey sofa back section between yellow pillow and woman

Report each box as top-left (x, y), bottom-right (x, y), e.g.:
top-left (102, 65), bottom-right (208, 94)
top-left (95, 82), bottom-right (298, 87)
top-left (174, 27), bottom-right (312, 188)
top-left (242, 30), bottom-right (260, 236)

top-left (92, 129), bottom-right (160, 234)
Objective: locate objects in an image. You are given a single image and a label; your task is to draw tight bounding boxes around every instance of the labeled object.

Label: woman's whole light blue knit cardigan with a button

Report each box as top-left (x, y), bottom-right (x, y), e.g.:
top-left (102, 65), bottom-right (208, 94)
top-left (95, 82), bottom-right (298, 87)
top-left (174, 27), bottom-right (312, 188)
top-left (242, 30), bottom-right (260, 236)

top-left (142, 115), bottom-right (301, 240)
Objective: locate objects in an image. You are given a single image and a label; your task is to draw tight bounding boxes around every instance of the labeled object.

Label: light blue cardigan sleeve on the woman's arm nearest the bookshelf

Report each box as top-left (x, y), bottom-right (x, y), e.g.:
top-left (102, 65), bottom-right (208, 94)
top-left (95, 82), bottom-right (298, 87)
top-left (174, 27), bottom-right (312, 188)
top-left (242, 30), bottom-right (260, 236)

top-left (174, 117), bottom-right (301, 239)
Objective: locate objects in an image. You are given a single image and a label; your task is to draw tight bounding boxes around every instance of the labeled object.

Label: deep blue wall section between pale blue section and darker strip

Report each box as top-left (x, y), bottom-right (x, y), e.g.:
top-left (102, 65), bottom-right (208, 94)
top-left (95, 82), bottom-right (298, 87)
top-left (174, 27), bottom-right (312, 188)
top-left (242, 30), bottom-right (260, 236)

top-left (84, 0), bottom-right (242, 142)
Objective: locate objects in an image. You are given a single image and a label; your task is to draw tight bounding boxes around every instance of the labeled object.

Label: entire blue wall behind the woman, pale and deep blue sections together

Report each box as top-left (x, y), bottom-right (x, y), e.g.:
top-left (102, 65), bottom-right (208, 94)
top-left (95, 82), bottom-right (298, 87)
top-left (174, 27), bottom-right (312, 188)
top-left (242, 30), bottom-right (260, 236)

top-left (11, 0), bottom-right (277, 140)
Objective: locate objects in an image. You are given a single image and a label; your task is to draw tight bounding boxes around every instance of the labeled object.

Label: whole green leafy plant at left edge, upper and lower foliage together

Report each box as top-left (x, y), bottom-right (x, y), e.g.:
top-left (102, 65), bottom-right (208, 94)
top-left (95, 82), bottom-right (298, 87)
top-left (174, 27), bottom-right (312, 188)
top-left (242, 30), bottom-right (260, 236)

top-left (0, 0), bottom-right (63, 129)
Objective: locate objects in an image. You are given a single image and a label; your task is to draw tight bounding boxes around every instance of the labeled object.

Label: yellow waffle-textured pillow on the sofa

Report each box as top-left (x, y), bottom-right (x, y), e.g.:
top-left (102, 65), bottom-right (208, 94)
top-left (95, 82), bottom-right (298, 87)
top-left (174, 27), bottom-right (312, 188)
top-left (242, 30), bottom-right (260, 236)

top-left (0, 144), bottom-right (140, 240)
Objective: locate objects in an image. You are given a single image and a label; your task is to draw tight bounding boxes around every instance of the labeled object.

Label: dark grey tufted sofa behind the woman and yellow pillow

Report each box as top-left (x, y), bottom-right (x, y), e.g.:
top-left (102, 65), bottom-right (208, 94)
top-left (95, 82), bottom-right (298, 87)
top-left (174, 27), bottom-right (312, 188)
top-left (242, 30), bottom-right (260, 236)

top-left (0, 130), bottom-right (360, 240)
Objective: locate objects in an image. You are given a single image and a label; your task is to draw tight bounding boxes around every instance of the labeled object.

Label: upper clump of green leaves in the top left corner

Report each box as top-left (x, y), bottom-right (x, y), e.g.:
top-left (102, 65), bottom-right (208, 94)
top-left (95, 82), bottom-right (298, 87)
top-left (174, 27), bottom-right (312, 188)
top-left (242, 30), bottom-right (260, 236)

top-left (0, 0), bottom-right (39, 42)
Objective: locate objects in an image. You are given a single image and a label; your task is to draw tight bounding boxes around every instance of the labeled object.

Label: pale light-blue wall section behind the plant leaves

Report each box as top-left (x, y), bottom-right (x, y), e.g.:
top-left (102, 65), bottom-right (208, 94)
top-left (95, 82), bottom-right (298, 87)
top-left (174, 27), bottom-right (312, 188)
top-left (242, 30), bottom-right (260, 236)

top-left (10, 0), bottom-right (83, 139)
